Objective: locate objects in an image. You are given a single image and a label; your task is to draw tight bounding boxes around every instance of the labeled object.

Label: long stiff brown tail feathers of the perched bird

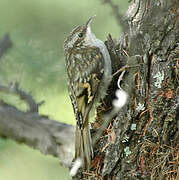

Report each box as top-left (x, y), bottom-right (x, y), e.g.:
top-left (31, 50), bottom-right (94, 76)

top-left (75, 123), bottom-right (93, 171)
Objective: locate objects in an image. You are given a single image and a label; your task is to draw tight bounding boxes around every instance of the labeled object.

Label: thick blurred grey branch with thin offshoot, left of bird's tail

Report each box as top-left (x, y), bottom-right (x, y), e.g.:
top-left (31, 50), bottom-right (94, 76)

top-left (0, 84), bottom-right (75, 167)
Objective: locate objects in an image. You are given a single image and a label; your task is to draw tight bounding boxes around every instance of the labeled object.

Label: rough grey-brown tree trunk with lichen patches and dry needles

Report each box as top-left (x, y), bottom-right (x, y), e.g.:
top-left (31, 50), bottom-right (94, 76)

top-left (79, 0), bottom-right (179, 180)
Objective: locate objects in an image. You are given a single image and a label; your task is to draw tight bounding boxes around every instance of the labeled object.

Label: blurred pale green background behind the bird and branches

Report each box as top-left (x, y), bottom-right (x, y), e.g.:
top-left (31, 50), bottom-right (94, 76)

top-left (0, 0), bottom-right (128, 180)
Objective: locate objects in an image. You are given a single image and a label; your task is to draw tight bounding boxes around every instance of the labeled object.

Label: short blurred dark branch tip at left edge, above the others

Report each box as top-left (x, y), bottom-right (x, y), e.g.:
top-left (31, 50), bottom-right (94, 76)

top-left (0, 34), bottom-right (12, 58)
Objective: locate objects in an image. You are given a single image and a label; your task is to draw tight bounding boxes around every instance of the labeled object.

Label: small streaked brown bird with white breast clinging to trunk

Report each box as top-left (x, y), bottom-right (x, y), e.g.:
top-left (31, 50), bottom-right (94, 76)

top-left (64, 16), bottom-right (112, 171)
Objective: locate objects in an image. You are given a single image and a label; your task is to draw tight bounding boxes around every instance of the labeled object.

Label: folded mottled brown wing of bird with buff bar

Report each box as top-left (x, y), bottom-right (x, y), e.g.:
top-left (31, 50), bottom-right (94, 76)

top-left (68, 48), bottom-right (104, 126)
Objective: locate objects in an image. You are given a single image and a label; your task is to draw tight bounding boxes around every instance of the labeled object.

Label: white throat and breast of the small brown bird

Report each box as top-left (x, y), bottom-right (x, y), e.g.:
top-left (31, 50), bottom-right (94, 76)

top-left (84, 27), bottom-right (112, 83)
